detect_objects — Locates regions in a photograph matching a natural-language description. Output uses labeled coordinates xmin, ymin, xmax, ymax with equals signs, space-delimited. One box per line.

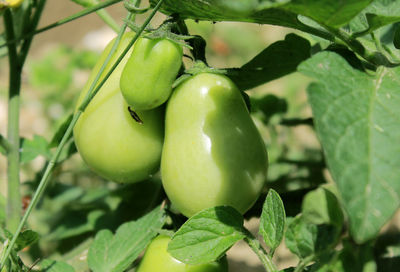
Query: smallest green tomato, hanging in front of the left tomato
xmin=120 ymin=38 xmax=183 ymax=110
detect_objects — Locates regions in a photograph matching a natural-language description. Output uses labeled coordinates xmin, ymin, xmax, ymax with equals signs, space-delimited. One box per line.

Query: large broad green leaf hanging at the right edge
xmin=299 ymin=52 xmax=400 ymax=242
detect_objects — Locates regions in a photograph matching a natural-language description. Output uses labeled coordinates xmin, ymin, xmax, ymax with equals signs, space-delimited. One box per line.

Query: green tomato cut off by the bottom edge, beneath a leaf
xmin=136 ymin=235 xmax=228 ymax=272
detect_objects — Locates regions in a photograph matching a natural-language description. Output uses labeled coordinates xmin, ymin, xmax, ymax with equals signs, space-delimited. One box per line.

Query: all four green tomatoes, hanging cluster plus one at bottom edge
xmin=74 ymin=32 xmax=267 ymax=272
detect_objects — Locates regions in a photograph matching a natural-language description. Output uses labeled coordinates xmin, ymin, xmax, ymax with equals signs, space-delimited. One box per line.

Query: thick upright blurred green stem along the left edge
xmin=4 ymin=9 xmax=22 ymax=232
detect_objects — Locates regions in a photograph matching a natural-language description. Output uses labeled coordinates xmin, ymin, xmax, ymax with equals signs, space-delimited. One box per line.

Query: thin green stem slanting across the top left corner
xmin=0 ymin=0 xmax=122 ymax=48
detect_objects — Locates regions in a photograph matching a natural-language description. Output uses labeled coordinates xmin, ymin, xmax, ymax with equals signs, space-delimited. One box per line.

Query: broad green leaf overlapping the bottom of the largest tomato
xmin=168 ymin=206 xmax=245 ymax=265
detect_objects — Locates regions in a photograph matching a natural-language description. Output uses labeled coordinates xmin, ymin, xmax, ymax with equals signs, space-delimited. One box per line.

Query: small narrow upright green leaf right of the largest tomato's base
xmin=259 ymin=189 xmax=286 ymax=255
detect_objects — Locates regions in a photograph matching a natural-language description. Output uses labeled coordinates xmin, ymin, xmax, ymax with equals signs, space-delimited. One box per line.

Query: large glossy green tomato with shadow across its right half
xmin=161 ymin=73 xmax=268 ymax=217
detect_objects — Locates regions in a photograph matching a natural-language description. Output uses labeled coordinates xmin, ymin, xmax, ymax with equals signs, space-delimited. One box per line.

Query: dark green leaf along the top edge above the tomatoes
xmin=150 ymin=0 xmax=372 ymax=30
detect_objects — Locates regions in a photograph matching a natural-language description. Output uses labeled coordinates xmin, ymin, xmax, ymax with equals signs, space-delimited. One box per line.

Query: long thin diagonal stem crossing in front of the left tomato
xmin=0 ymin=0 xmax=164 ymax=269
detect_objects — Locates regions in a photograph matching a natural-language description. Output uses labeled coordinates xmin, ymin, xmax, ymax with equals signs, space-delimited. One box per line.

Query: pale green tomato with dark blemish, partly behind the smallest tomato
xmin=74 ymin=33 xmax=164 ymax=182
